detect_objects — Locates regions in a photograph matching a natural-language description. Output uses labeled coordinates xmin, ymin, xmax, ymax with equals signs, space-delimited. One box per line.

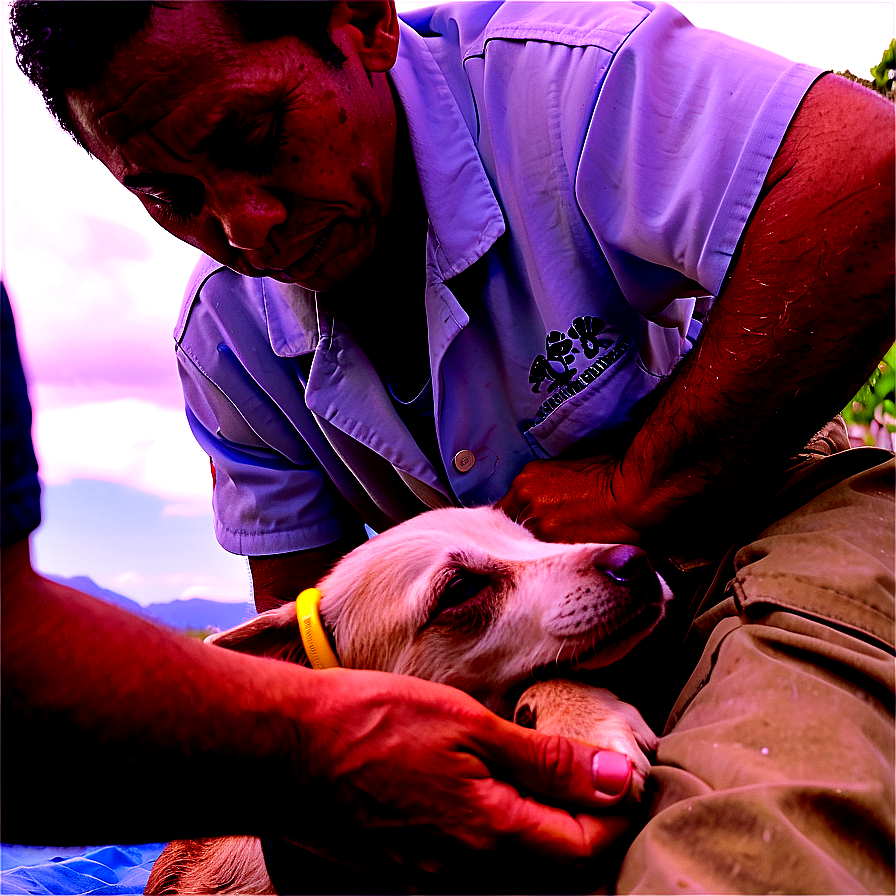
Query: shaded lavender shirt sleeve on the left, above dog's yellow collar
xmin=177 ymin=272 xmax=361 ymax=556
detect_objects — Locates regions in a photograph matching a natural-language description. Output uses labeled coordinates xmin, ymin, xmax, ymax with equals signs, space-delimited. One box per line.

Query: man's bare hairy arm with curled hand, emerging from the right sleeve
xmin=500 ymin=75 xmax=894 ymax=542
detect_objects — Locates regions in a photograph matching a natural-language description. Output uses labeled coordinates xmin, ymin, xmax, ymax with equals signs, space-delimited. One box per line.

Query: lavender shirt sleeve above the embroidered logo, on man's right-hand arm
xmin=576 ymin=3 xmax=821 ymax=322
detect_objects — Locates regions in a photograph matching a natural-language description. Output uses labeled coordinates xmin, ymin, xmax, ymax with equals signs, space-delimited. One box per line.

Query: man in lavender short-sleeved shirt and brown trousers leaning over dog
xmin=8 ymin=3 xmax=893 ymax=890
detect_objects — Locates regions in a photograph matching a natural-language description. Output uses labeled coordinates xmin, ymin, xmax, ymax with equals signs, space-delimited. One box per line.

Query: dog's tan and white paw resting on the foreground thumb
xmin=513 ymin=679 xmax=659 ymax=800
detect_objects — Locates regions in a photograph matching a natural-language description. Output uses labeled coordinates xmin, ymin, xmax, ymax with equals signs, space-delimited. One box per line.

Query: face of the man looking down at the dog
xmin=68 ymin=3 xmax=395 ymax=290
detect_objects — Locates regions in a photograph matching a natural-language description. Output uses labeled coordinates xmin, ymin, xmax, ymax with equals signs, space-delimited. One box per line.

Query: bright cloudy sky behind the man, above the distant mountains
xmin=0 ymin=0 xmax=896 ymax=605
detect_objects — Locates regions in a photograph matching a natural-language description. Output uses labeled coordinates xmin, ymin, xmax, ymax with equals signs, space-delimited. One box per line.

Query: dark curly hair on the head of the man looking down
xmin=10 ymin=0 xmax=345 ymax=149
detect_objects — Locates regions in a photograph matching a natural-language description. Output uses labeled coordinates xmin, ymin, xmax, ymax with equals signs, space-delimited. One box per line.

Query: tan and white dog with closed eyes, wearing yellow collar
xmin=145 ymin=507 xmax=672 ymax=894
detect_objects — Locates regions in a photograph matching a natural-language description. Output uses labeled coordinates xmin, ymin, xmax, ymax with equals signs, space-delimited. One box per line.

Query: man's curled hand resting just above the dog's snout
xmin=497 ymin=457 xmax=642 ymax=544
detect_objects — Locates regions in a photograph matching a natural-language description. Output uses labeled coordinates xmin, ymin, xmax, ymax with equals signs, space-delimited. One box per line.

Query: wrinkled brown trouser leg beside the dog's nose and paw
xmin=616 ymin=449 xmax=896 ymax=893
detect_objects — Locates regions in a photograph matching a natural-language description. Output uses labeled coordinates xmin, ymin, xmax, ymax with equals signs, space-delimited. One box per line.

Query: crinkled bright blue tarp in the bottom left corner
xmin=0 ymin=843 xmax=165 ymax=896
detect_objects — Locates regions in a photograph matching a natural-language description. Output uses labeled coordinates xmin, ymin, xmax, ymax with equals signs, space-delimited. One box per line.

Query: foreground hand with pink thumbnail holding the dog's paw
xmin=296 ymin=669 xmax=631 ymax=871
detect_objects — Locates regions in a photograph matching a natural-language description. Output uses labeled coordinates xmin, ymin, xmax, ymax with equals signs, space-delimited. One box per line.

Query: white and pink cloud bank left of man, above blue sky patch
xmin=0 ymin=40 xmax=211 ymax=514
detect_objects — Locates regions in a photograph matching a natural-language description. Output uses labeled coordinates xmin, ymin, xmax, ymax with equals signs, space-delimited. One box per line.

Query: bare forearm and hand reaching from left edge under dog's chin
xmin=0 ymin=541 xmax=627 ymax=861
